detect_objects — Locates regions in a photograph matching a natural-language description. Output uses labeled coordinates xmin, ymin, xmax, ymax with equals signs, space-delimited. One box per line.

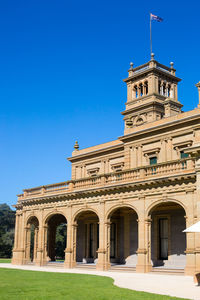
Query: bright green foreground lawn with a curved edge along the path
xmin=0 ymin=268 xmax=189 ymax=300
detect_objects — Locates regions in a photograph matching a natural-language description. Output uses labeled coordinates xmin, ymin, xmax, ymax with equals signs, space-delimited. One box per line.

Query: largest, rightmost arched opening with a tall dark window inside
xmin=150 ymin=201 xmax=186 ymax=269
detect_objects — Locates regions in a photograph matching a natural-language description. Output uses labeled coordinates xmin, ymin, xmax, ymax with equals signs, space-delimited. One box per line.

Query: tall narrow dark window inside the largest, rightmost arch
xmin=159 ymin=218 xmax=168 ymax=260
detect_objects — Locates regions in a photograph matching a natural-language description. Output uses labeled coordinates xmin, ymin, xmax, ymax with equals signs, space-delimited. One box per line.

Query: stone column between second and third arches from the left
xmin=64 ymin=222 xmax=78 ymax=268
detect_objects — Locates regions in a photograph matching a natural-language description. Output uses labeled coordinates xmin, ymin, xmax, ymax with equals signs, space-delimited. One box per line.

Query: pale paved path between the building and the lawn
xmin=0 ymin=263 xmax=200 ymax=300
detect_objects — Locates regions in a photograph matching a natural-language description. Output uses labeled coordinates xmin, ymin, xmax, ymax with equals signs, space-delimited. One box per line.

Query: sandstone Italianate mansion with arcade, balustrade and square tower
xmin=12 ymin=54 xmax=200 ymax=275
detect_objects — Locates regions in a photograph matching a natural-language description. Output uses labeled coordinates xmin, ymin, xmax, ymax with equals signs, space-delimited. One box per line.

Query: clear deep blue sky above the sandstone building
xmin=0 ymin=0 xmax=200 ymax=205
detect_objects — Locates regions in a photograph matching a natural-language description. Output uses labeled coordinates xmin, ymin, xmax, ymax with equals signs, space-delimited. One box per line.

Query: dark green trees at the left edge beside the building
xmin=0 ymin=203 xmax=15 ymax=258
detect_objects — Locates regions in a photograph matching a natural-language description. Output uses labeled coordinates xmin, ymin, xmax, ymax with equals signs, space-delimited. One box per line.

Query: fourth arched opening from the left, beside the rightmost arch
xmin=109 ymin=207 xmax=138 ymax=267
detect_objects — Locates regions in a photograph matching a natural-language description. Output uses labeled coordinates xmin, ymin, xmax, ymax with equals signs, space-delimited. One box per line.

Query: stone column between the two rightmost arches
xmin=136 ymin=217 xmax=152 ymax=273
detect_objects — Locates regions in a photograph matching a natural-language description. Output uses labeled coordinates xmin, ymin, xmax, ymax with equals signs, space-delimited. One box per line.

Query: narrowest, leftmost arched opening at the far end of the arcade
xmin=25 ymin=216 xmax=39 ymax=262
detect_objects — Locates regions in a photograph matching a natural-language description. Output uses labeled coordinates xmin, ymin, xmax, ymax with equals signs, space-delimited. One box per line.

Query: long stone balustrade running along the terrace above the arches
xmin=18 ymin=158 xmax=194 ymax=200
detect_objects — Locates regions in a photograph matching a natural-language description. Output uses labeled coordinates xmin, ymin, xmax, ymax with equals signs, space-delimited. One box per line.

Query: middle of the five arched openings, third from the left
xmin=75 ymin=211 xmax=99 ymax=264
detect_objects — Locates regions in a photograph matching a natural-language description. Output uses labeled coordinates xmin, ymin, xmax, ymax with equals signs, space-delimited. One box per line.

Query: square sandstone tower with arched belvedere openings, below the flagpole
xmin=122 ymin=53 xmax=182 ymax=134
